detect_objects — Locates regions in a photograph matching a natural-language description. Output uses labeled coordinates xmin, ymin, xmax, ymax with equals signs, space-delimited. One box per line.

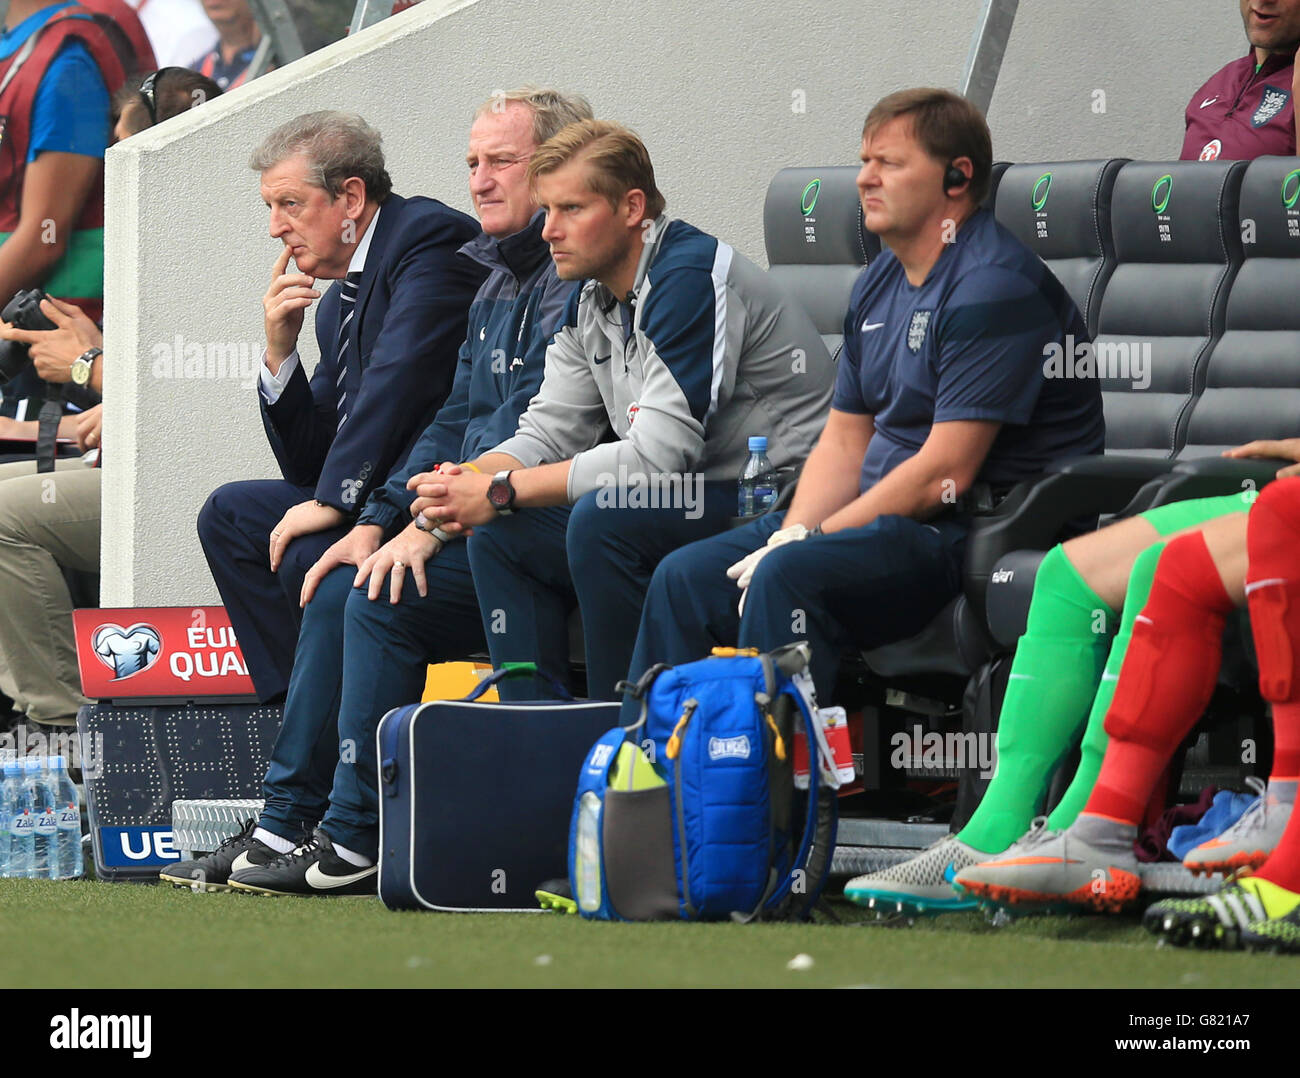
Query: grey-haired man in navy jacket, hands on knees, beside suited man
xmin=163 ymin=91 xmax=590 ymax=895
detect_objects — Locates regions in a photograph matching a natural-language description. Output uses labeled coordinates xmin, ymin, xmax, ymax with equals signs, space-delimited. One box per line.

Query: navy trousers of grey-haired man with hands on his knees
xmin=259 ymin=542 xmax=485 ymax=857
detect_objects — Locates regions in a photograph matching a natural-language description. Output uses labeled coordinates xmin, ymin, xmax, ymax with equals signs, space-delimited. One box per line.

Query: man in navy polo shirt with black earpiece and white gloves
xmin=613 ymin=88 xmax=1105 ymax=719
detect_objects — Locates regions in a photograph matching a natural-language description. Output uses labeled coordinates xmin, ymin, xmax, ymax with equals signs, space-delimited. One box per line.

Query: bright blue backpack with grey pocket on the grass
xmin=569 ymin=644 xmax=839 ymax=921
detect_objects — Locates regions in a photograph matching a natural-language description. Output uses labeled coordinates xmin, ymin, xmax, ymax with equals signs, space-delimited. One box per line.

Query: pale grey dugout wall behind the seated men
xmin=101 ymin=0 xmax=1245 ymax=606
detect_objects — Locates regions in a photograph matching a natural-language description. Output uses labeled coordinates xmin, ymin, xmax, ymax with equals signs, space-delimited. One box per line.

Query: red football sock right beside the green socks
xmin=1083 ymin=532 xmax=1232 ymax=824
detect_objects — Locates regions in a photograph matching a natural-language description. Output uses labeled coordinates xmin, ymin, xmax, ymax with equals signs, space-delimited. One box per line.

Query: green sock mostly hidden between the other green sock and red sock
xmin=1048 ymin=492 xmax=1253 ymax=831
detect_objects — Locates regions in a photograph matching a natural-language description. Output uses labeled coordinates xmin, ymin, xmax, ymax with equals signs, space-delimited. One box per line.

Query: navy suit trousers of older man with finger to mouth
xmin=199 ymin=479 xmax=348 ymax=702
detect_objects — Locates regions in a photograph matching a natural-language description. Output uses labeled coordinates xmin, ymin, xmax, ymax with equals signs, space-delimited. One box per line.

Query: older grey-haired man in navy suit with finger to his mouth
xmin=199 ymin=112 xmax=486 ymax=700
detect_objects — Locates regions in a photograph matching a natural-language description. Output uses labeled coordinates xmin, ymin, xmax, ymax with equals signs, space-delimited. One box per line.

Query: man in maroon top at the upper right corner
xmin=1179 ymin=0 xmax=1300 ymax=161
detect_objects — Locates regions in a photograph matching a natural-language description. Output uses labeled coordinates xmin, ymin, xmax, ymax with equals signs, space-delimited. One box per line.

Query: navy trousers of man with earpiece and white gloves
xmin=623 ymin=512 xmax=969 ymax=724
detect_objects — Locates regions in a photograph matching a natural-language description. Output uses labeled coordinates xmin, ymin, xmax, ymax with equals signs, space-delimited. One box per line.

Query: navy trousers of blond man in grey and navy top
xmin=469 ymin=482 xmax=736 ymax=700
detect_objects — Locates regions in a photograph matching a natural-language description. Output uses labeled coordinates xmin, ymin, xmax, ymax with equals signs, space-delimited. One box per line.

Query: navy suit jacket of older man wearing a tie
xmin=257 ymin=195 xmax=488 ymax=516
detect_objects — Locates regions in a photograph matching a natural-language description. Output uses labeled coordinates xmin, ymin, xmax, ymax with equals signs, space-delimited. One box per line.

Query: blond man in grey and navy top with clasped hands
xmin=417 ymin=121 xmax=833 ymax=698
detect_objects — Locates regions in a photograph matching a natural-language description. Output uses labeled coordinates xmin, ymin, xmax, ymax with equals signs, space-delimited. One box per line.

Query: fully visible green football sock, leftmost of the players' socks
xmin=957 ymin=546 xmax=1115 ymax=853
